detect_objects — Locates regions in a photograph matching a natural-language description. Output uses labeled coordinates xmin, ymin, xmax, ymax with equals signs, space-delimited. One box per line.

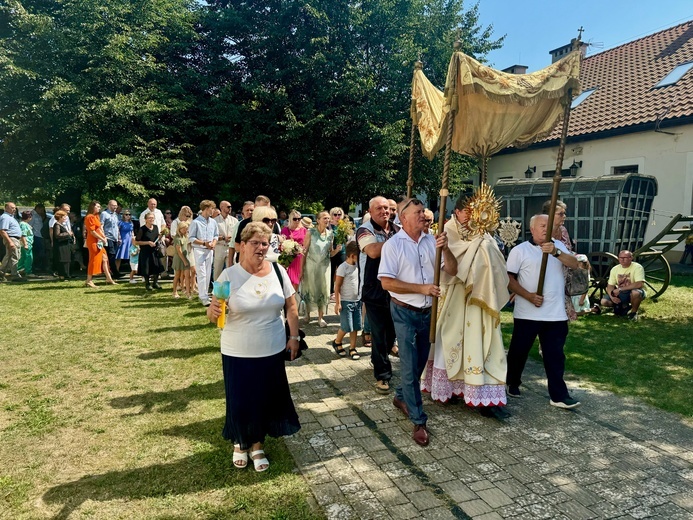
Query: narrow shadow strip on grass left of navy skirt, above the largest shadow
xmin=111 ymin=379 xmax=225 ymax=417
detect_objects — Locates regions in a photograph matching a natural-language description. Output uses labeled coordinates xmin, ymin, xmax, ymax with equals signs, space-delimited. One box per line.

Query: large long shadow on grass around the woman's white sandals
xmin=42 ymin=417 xmax=304 ymax=520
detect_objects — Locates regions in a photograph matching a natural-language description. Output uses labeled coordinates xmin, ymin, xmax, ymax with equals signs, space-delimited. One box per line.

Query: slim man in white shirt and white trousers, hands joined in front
xmin=188 ymin=200 xmax=219 ymax=307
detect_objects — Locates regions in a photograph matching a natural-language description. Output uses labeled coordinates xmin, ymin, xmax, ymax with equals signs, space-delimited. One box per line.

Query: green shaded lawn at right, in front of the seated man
xmin=503 ymin=276 xmax=693 ymax=417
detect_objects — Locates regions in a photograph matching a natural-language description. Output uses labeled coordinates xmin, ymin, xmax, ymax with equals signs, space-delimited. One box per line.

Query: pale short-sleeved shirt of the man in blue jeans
xmin=378 ymin=229 xmax=436 ymax=309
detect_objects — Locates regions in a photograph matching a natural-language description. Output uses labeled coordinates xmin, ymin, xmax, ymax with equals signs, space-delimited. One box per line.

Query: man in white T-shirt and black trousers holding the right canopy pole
xmin=506 ymin=215 xmax=580 ymax=409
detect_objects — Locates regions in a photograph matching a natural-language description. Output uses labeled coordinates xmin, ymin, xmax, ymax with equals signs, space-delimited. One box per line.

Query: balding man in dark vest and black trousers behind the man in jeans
xmin=356 ymin=196 xmax=399 ymax=394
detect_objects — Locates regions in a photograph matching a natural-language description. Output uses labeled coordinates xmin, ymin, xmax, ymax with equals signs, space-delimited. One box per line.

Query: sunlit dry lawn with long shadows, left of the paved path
xmin=0 ymin=281 xmax=322 ymax=520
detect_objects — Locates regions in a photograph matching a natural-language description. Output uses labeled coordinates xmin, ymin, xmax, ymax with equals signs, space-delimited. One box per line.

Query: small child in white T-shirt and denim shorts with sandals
xmin=332 ymin=241 xmax=361 ymax=360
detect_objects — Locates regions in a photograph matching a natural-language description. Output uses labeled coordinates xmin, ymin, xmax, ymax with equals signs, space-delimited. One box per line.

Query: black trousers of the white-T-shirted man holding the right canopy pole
xmin=506 ymin=319 xmax=568 ymax=401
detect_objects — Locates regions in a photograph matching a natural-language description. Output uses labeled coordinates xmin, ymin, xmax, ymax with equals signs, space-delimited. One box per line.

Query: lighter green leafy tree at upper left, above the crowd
xmin=0 ymin=0 xmax=200 ymax=203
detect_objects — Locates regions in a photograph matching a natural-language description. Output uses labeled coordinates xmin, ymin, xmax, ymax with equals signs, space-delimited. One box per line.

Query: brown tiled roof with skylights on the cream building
xmin=542 ymin=21 xmax=693 ymax=142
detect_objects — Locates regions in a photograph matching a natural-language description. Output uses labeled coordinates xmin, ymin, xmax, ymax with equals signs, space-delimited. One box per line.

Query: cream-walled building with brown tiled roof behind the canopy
xmin=488 ymin=21 xmax=693 ymax=259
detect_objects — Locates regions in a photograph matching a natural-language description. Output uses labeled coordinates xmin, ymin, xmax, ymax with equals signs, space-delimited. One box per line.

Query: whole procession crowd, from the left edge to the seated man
xmin=0 ymin=195 xmax=645 ymax=471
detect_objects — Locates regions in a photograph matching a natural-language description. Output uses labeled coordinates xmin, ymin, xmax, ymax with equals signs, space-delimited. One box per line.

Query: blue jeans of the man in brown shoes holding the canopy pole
xmin=390 ymin=302 xmax=431 ymax=424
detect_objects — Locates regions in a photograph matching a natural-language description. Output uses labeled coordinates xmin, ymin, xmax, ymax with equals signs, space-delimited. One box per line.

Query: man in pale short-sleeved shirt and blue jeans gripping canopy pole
xmin=378 ymin=199 xmax=457 ymax=446
